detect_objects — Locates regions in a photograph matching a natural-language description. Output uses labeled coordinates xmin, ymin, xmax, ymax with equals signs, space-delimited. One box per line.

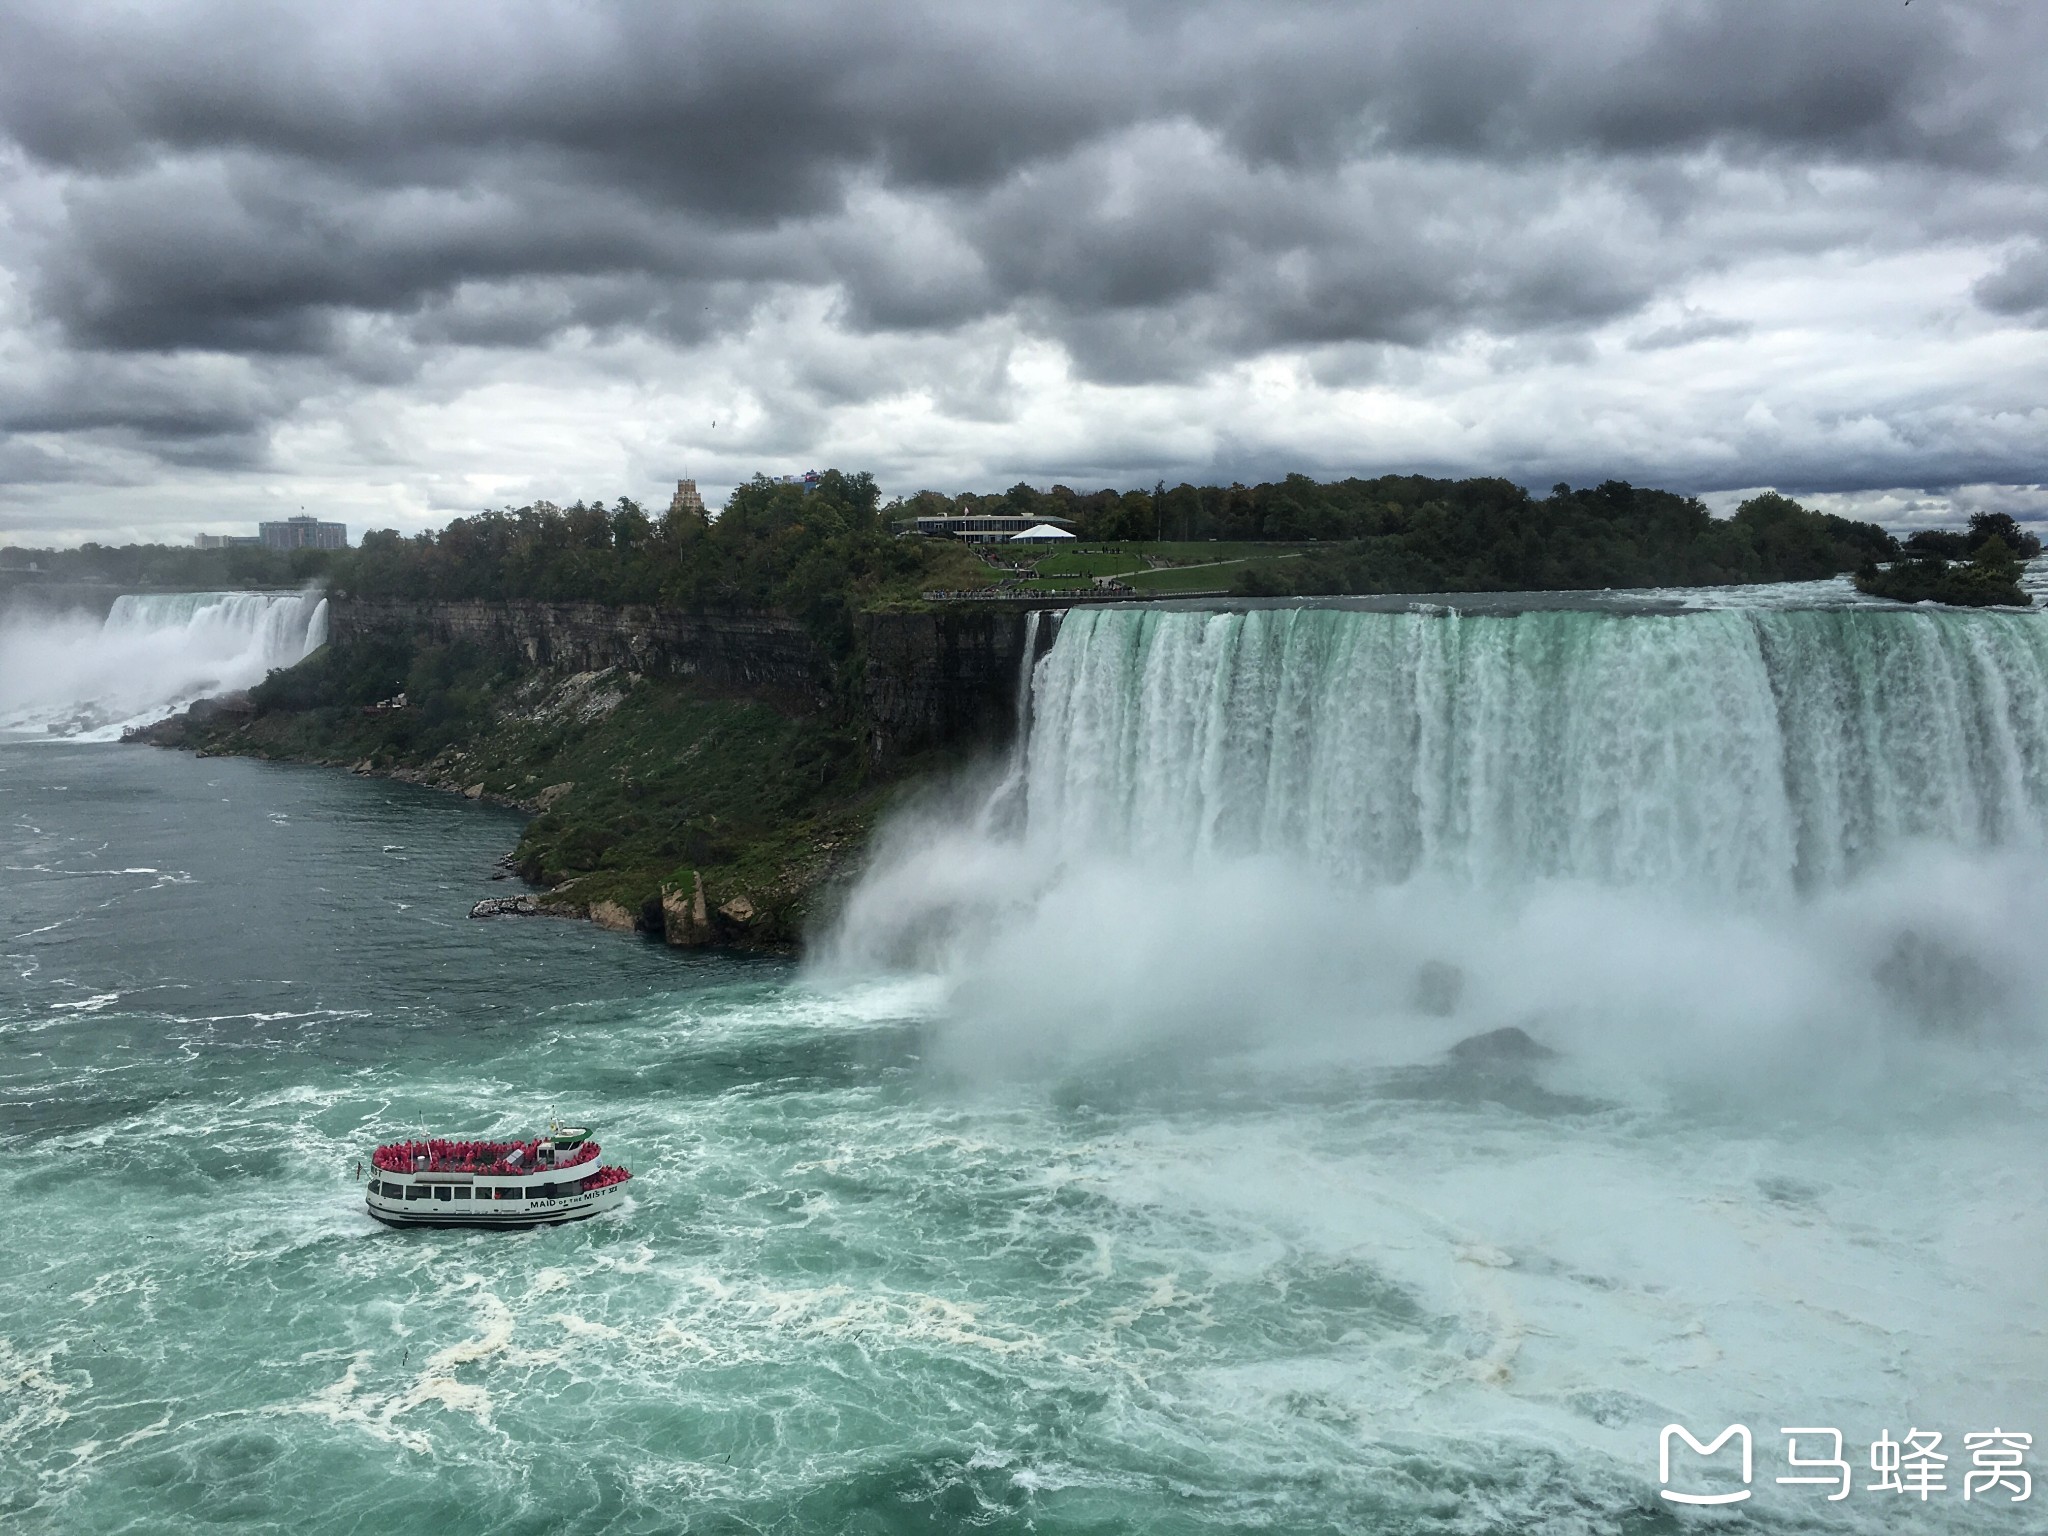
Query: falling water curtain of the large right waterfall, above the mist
xmin=1028 ymin=608 xmax=2048 ymax=897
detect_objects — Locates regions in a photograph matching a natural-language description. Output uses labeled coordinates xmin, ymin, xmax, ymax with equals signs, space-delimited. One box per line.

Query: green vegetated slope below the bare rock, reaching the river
xmin=156 ymin=639 xmax=883 ymax=948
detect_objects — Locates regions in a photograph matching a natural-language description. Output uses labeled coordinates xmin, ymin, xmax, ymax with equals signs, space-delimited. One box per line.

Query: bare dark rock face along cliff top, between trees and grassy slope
xmin=328 ymin=594 xmax=1051 ymax=772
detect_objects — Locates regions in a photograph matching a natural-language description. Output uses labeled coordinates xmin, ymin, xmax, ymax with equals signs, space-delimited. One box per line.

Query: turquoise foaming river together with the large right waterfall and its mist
xmin=0 ymin=593 xmax=2048 ymax=1532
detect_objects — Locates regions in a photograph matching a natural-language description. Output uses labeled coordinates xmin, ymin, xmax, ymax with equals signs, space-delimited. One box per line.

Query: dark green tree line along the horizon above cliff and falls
xmin=8 ymin=469 xmax=1998 ymax=626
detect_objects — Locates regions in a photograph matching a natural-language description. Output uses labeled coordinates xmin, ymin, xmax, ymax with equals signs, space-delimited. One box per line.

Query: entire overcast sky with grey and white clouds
xmin=0 ymin=0 xmax=2048 ymax=543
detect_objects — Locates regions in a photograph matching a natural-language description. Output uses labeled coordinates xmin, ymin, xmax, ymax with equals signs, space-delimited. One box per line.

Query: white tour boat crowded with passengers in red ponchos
xmin=369 ymin=1124 xmax=633 ymax=1227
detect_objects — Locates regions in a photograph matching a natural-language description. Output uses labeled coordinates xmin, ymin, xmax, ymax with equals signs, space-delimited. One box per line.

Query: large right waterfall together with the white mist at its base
xmin=834 ymin=608 xmax=2048 ymax=1055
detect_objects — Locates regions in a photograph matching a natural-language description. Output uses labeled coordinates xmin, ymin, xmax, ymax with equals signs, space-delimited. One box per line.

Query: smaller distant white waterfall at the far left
xmin=0 ymin=590 xmax=328 ymax=739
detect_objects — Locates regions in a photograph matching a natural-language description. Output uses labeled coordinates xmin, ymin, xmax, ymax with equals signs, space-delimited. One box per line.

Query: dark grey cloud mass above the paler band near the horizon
xmin=0 ymin=0 xmax=2048 ymax=536
